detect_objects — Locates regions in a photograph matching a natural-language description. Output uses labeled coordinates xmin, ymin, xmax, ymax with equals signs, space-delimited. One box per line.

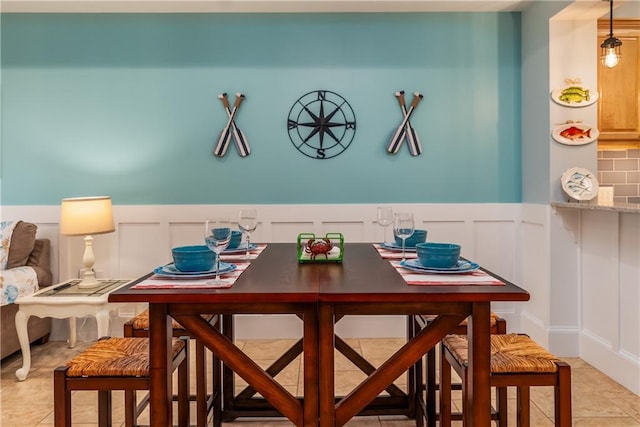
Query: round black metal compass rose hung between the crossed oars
xmin=287 ymin=90 xmax=356 ymax=159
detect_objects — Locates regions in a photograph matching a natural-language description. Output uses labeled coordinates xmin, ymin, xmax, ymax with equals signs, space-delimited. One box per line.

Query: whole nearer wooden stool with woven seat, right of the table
xmin=440 ymin=334 xmax=572 ymax=427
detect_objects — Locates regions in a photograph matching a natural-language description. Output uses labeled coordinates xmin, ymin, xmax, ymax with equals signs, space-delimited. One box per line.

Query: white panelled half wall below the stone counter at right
xmin=550 ymin=206 xmax=640 ymax=394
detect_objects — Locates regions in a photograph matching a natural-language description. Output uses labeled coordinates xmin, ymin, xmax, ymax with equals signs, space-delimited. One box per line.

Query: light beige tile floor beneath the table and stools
xmin=0 ymin=339 xmax=640 ymax=427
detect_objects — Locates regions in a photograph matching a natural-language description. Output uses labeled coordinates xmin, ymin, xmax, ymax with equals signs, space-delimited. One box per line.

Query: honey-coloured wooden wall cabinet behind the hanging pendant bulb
xmin=598 ymin=19 xmax=640 ymax=147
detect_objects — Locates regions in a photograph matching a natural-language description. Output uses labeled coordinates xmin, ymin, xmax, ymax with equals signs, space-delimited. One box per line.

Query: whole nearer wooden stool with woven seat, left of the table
xmin=53 ymin=337 xmax=189 ymax=427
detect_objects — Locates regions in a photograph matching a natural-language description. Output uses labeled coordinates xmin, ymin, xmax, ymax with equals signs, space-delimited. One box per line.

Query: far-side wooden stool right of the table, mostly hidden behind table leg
xmin=409 ymin=312 xmax=507 ymax=427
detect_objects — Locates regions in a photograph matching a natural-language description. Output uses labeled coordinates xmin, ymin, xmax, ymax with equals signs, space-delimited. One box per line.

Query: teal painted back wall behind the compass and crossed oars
xmin=0 ymin=13 xmax=522 ymax=205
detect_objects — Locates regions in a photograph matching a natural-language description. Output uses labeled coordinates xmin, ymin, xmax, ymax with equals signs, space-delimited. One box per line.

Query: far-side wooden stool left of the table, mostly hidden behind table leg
xmin=124 ymin=309 xmax=222 ymax=427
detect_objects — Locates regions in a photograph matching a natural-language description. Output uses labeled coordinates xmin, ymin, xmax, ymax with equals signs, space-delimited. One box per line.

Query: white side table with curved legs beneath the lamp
xmin=16 ymin=279 xmax=131 ymax=381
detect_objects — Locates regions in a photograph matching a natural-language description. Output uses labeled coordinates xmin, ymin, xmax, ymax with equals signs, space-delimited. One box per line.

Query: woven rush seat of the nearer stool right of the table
xmin=443 ymin=334 xmax=559 ymax=374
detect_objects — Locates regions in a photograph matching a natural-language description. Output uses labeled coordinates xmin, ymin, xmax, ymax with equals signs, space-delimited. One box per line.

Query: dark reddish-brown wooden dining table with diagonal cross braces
xmin=109 ymin=243 xmax=529 ymax=427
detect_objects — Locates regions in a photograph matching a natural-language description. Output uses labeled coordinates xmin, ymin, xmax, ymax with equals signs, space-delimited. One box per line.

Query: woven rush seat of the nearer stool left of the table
xmin=67 ymin=338 xmax=184 ymax=377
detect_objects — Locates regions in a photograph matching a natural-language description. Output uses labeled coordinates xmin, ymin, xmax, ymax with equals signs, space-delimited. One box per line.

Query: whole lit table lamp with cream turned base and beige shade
xmin=60 ymin=196 xmax=115 ymax=288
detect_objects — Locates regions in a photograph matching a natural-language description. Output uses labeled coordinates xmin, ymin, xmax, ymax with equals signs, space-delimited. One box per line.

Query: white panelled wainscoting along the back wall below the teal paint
xmin=2 ymin=204 xmax=523 ymax=339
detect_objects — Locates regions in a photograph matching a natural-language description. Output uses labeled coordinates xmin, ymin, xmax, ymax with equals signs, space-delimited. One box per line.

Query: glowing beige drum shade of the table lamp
xmin=60 ymin=196 xmax=115 ymax=236
